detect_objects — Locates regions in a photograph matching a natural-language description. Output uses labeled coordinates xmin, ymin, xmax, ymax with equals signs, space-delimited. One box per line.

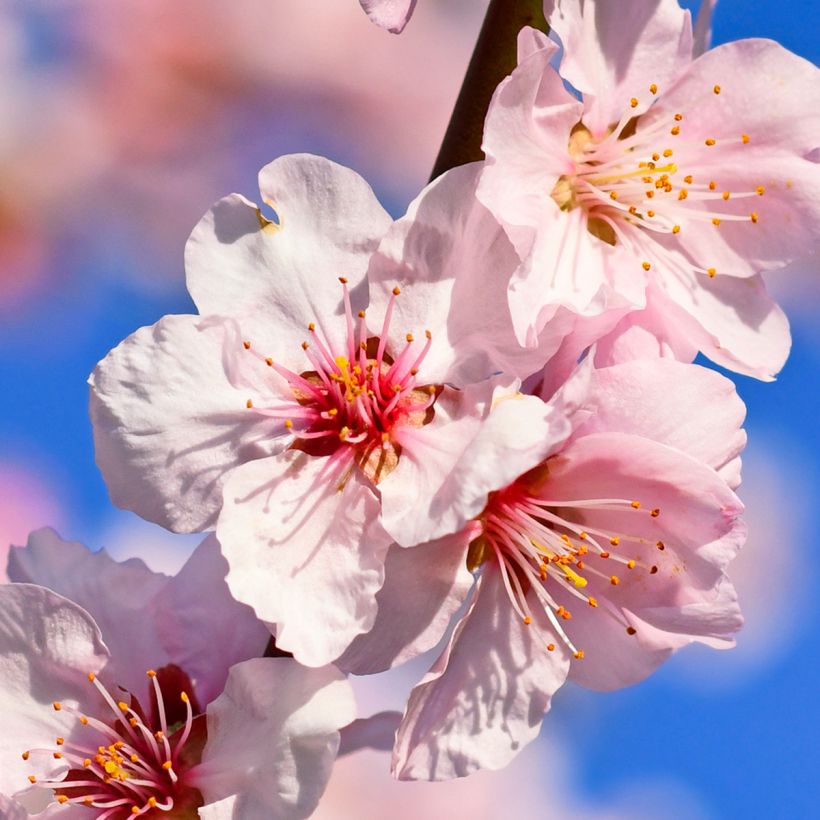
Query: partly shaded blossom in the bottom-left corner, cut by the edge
xmin=0 ymin=530 xmax=354 ymax=820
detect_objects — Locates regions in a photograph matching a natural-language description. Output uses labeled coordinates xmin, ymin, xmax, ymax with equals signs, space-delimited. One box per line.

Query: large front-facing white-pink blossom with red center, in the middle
xmin=91 ymin=155 xmax=540 ymax=666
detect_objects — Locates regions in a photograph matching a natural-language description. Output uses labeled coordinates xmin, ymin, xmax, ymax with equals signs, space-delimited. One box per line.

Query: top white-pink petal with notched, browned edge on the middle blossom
xmin=185 ymin=154 xmax=391 ymax=355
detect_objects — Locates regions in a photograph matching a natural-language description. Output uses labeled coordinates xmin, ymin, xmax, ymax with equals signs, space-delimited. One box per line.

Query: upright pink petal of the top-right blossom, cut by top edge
xmin=544 ymin=0 xmax=692 ymax=136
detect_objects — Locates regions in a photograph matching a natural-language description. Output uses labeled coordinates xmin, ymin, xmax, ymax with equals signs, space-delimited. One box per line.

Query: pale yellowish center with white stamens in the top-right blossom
xmin=552 ymin=83 xmax=765 ymax=276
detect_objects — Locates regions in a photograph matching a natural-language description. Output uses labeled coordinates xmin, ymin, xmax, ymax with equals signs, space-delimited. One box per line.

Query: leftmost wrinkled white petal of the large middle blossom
xmin=89 ymin=316 xmax=283 ymax=532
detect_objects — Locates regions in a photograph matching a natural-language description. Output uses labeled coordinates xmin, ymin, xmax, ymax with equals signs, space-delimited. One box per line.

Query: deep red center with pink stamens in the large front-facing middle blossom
xmin=244 ymin=278 xmax=439 ymax=483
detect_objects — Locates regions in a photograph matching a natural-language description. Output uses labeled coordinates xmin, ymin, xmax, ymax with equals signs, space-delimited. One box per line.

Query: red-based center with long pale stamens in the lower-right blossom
xmin=467 ymin=463 xmax=665 ymax=659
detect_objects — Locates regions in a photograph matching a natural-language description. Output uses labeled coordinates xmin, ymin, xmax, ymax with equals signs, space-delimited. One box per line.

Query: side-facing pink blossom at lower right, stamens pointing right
xmin=350 ymin=359 xmax=745 ymax=780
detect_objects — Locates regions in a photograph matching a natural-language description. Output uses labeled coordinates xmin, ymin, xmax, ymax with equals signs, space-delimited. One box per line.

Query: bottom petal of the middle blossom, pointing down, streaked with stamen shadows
xmin=217 ymin=450 xmax=390 ymax=666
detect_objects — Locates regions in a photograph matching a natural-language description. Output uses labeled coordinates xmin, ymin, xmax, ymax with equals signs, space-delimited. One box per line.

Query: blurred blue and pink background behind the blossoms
xmin=0 ymin=0 xmax=820 ymax=820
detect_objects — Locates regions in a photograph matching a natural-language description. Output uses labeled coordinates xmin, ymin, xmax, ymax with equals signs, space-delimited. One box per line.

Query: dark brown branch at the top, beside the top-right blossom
xmin=430 ymin=0 xmax=548 ymax=180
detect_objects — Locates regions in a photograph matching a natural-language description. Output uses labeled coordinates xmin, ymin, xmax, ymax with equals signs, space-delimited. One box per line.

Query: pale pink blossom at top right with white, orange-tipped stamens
xmin=478 ymin=0 xmax=820 ymax=379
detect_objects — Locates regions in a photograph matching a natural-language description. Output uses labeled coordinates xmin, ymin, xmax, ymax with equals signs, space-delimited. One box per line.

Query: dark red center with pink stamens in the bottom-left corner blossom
xmin=23 ymin=666 xmax=202 ymax=820
